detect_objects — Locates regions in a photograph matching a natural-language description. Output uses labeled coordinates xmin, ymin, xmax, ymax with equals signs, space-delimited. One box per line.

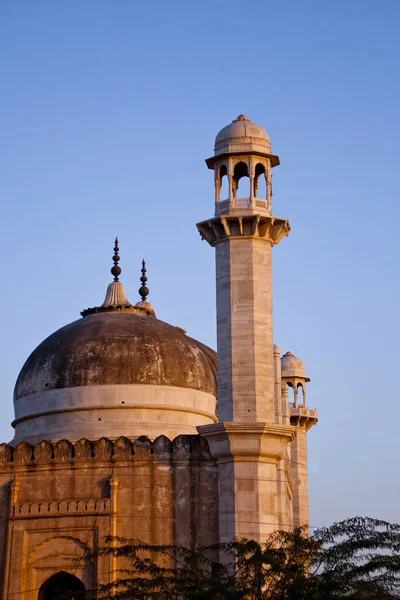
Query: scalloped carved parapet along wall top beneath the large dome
xmin=0 ymin=435 xmax=216 ymax=470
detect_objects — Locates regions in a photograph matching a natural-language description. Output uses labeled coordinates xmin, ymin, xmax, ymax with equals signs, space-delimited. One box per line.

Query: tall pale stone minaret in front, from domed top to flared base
xmin=197 ymin=115 xmax=295 ymax=541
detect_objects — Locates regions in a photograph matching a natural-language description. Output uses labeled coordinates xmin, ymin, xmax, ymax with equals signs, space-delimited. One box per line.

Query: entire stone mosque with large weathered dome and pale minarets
xmin=0 ymin=115 xmax=317 ymax=600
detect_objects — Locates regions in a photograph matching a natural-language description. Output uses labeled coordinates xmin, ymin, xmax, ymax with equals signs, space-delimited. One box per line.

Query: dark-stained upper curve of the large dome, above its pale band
xmin=14 ymin=312 xmax=216 ymax=400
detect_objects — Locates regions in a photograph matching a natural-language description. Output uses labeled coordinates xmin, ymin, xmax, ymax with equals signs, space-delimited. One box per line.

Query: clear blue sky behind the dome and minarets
xmin=0 ymin=0 xmax=400 ymax=525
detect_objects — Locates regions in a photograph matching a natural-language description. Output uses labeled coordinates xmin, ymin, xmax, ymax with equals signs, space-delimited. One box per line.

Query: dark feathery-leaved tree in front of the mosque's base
xmin=89 ymin=517 xmax=400 ymax=600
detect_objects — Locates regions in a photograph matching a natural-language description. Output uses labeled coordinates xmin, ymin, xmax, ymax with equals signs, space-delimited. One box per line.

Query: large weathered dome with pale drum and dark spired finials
xmin=13 ymin=242 xmax=216 ymax=443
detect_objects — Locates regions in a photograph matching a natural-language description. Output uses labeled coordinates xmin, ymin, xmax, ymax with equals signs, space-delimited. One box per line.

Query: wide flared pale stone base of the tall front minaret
xmin=197 ymin=422 xmax=295 ymax=543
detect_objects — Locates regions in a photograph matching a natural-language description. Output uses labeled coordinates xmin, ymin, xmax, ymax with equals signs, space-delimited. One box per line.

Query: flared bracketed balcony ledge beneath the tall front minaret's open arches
xmin=196 ymin=214 xmax=290 ymax=246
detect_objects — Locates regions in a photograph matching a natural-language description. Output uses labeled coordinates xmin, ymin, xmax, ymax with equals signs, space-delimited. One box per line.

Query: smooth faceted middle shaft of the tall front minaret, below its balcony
xmin=216 ymin=237 xmax=276 ymax=423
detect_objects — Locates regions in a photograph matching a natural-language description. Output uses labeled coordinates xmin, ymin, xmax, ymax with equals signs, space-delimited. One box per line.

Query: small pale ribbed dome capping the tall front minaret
xmin=214 ymin=115 xmax=271 ymax=156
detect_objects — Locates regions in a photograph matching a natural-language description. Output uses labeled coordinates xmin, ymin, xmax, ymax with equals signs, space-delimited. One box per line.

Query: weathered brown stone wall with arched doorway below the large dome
xmin=0 ymin=435 xmax=219 ymax=600
